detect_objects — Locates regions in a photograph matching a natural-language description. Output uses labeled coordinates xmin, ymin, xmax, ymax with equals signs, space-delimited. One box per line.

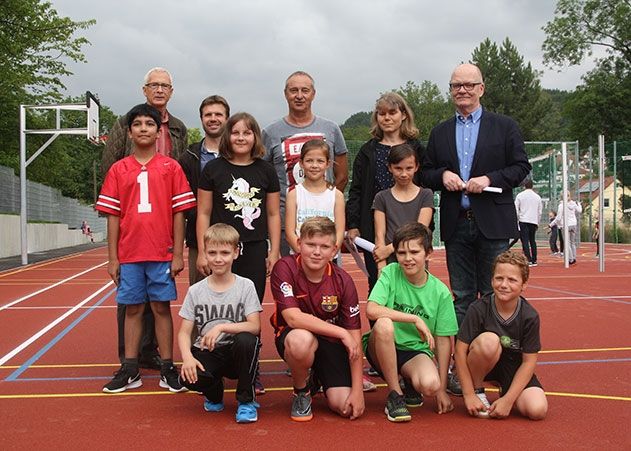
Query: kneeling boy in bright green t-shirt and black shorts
xmin=364 ymin=223 xmax=458 ymax=422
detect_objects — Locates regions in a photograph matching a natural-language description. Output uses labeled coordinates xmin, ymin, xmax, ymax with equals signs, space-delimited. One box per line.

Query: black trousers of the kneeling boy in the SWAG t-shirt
xmin=182 ymin=332 xmax=259 ymax=403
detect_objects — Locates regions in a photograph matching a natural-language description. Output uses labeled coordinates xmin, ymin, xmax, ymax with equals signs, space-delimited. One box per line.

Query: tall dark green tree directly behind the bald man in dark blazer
xmin=471 ymin=38 xmax=560 ymax=141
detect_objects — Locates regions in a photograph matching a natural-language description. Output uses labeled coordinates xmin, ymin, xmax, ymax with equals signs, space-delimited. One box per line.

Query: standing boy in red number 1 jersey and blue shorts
xmin=96 ymin=104 xmax=195 ymax=393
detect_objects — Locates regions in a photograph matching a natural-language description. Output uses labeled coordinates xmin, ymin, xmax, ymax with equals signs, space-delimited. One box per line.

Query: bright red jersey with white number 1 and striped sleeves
xmin=96 ymin=154 xmax=196 ymax=263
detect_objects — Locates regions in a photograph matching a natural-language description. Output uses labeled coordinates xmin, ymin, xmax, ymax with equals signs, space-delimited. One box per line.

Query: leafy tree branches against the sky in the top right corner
xmin=543 ymin=0 xmax=631 ymax=67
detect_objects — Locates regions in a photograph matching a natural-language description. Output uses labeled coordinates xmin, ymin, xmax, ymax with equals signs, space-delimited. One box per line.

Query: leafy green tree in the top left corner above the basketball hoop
xmin=0 ymin=0 xmax=95 ymax=167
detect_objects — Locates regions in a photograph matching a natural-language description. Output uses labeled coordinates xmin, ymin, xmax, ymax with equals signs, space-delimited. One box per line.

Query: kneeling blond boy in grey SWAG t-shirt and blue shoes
xmin=178 ymin=223 xmax=262 ymax=423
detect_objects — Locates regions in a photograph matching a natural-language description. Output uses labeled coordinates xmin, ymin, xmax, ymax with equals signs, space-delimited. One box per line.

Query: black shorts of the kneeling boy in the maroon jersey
xmin=276 ymin=327 xmax=352 ymax=391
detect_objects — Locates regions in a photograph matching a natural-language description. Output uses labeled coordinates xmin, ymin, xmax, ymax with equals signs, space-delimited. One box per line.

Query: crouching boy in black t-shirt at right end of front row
xmin=455 ymin=251 xmax=548 ymax=420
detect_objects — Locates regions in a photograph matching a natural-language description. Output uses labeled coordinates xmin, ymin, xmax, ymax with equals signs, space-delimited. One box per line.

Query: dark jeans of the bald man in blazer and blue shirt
xmin=445 ymin=218 xmax=508 ymax=326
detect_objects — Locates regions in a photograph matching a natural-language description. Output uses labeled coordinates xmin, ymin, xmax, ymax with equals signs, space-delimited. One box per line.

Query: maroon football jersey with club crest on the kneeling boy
xmin=270 ymin=255 xmax=361 ymax=335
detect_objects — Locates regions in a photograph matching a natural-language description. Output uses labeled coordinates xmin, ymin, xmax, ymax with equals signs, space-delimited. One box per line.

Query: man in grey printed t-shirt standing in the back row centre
xmin=263 ymin=71 xmax=348 ymax=255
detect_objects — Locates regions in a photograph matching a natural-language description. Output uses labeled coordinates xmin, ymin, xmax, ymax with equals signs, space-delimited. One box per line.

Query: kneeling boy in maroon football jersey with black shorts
xmin=270 ymin=216 xmax=364 ymax=421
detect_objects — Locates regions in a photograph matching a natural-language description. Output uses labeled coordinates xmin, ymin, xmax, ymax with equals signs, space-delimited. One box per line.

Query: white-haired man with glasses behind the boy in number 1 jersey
xmin=101 ymin=67 xmax=188 ymax=370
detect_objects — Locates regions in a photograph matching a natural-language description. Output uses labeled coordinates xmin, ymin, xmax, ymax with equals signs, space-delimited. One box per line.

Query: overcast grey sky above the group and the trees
xmin=51 ymin=0 xmax=593 ymax=132
